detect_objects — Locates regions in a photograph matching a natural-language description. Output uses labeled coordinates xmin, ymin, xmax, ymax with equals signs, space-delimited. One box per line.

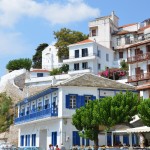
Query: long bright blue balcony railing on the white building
xmin=14 ymin=106 xmax=58 ymax=124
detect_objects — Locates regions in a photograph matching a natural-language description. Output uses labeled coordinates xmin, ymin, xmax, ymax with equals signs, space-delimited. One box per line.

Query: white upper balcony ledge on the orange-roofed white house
xmin=63 ymin=53 xmax=98 ymax=63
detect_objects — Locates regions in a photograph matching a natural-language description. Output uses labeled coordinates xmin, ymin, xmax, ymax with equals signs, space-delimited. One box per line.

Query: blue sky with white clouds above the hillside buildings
xmin=0 ymin=0 xmax=150 ymax=77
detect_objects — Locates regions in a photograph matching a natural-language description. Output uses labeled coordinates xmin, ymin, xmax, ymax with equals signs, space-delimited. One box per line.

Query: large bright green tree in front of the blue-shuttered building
xmin=72 ymin=91 xmax=139 ymax=146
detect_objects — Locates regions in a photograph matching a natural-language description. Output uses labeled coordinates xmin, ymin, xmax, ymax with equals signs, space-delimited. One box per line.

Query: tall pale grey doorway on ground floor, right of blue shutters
xmin=39 ymin=129 xmax=47 ymax=150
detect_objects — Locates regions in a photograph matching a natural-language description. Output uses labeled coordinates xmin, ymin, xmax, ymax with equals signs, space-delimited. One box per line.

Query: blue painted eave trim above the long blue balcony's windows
xmin=18 ymin=88 xmax=58 ymax=105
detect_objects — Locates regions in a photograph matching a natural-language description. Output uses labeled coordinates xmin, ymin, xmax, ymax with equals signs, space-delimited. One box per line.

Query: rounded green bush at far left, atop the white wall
xmin=6 ymin=58 xmax=32 ymax=71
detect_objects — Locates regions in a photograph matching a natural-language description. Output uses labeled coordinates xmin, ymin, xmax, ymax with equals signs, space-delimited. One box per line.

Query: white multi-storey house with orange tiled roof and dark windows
xmin=63 ymin=39 xmax=115 ymax=75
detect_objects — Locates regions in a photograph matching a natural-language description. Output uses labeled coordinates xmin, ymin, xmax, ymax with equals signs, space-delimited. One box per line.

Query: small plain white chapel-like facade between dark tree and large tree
xmin=42 ymin=45 xmax=62 ymax=71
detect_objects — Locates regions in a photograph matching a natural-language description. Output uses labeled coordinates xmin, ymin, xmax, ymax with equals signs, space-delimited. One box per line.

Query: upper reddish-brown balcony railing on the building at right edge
xmin=127 ymin=52 xmax=150 ymax=64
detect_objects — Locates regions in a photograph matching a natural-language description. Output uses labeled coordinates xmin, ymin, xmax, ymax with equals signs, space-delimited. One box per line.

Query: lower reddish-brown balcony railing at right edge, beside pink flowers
xmin=128 ymin=72 xmax=150 ymax=82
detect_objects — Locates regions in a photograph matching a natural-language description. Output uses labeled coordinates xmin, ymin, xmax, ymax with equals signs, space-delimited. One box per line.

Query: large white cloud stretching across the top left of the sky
xmin=0 ymin=0 xmax=100 ymax=27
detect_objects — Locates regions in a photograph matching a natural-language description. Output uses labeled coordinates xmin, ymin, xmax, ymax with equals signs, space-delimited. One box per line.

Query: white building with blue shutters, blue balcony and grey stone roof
xmin=15 ymin=74 xmax=135 ymax=150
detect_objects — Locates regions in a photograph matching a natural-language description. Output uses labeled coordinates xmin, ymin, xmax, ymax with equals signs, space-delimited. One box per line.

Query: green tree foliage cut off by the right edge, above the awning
xmin=138 ymin=98 xmax=150 ymax=126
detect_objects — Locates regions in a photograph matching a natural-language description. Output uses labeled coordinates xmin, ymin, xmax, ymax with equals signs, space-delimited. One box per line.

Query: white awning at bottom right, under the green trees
xmin=126 ymin=126 xmax=150 ymax=133
